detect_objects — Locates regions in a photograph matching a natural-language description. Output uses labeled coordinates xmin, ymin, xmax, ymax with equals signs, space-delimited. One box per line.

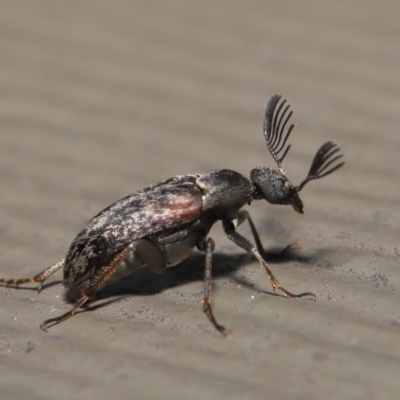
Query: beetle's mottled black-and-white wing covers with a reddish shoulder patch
xmin=64 ymin=175 xmax=203 ymax=286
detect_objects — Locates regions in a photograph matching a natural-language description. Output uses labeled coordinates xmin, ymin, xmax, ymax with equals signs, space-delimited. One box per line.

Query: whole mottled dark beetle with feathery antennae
xmin=0 ymin=95 xmax=344 ymax=336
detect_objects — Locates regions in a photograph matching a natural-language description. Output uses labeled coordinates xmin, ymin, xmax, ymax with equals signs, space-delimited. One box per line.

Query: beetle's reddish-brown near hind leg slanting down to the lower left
xmin=40 ymin=246 xmax=132 ymax=331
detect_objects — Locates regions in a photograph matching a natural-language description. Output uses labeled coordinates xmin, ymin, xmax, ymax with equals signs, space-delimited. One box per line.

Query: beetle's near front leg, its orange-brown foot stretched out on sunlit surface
xmin=223 ymin=210 xmax=316 ymax=301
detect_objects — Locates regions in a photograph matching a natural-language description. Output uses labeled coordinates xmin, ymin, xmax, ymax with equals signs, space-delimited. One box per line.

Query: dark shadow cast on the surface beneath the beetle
xmin=88 ymin=244 xmax=329 ymax=310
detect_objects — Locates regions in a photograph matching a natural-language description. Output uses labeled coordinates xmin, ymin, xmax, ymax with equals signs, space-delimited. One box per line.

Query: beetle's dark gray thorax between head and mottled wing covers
xmin=196 ymin=169 xmax=252 ymax=219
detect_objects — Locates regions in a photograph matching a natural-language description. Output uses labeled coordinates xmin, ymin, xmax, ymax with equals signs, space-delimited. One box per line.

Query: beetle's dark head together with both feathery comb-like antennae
xmin=250 ymin=95 xmax=344 ymax=214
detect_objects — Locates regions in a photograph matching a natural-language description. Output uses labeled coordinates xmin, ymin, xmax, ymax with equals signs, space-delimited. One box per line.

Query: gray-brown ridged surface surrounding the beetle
xmin=0 ymin=0 xmax=400 ymax=400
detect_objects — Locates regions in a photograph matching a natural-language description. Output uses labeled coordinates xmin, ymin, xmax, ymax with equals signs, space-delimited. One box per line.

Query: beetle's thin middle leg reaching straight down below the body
xmin=198 ymin=238 xmax=231 ymax=336
